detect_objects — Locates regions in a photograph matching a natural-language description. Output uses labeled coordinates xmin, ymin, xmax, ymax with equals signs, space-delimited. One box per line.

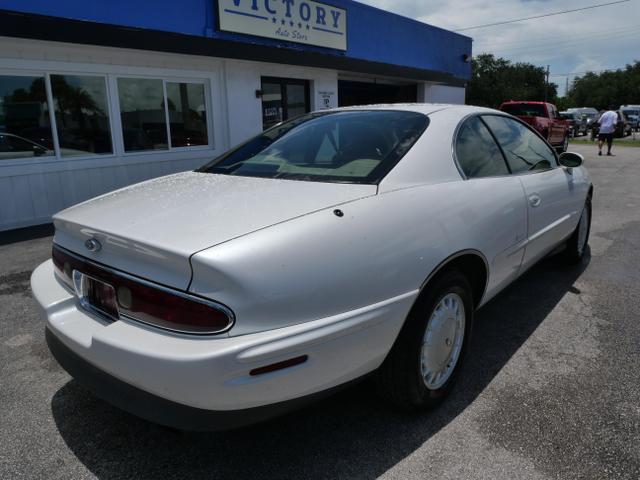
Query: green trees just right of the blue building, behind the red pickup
xmin=467 ymin=53 xmax=558 ymax=108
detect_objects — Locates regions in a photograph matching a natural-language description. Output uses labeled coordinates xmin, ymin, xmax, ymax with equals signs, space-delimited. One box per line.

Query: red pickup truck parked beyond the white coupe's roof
xmin=500 ymin=100 xmax=570 ymax=153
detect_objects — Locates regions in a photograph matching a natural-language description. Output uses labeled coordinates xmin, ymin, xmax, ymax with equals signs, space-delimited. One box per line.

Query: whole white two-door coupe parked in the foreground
xmin=31 ymin=105 xmax=593 ymax=430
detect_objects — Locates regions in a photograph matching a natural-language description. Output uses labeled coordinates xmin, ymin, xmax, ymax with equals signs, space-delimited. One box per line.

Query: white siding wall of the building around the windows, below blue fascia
xmin=0 ymin=37 xmax=338 ymax=231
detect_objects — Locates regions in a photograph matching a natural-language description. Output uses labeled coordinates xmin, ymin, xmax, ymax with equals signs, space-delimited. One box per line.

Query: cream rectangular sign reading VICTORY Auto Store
xmin=218 ymin=0 xmax=347 ymax=50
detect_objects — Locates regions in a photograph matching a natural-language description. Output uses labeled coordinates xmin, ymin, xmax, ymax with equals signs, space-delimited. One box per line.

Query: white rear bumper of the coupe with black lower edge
xmin=31 ymin=261 xmax=417 ymax=430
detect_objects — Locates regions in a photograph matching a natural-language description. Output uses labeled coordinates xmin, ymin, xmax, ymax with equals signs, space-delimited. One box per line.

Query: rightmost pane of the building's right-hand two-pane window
xmin=167 ymin=82 xmax=209 ymax=148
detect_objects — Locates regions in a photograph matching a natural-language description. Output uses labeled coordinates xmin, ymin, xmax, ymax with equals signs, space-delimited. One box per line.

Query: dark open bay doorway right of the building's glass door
xmin=338 ymin=80 xmax=418 ymax=107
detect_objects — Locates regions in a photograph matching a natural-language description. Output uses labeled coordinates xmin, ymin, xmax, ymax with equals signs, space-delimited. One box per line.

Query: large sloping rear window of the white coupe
xmin=198 ymin=110 xmax=429 ymax=183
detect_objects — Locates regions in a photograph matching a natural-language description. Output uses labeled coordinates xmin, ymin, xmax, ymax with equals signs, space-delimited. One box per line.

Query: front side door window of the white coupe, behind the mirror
xmin=482 ymin=115 xmax=558 ymax=174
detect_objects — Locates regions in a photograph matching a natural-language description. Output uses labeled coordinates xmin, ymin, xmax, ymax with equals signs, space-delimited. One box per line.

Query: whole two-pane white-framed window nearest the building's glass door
xmin=118 ymin=78 xmax=209 ymax=152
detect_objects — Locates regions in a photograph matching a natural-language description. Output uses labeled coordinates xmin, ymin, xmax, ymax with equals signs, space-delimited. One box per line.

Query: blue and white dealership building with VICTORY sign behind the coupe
xmin=0 ymin=0 xmax=471 ymax=231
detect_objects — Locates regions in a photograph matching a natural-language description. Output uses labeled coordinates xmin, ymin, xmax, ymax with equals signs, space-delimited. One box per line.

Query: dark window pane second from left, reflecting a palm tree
xmin=51 ymin=75 xmax=113 ymax=157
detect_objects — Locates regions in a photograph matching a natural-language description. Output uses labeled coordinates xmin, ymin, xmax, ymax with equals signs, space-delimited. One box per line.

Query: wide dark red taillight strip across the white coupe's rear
xmin=52 ymin=245 xmax=233 ymax=334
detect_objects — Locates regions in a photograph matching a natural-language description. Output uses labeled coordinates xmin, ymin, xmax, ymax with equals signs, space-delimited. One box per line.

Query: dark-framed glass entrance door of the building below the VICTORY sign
xmin=262 ymin=77 xmax=311 ymax=130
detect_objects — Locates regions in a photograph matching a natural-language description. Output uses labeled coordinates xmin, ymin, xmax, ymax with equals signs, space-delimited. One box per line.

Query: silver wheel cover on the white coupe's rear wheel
xmin=420 ymin=293 xmax=465 ymax=390
